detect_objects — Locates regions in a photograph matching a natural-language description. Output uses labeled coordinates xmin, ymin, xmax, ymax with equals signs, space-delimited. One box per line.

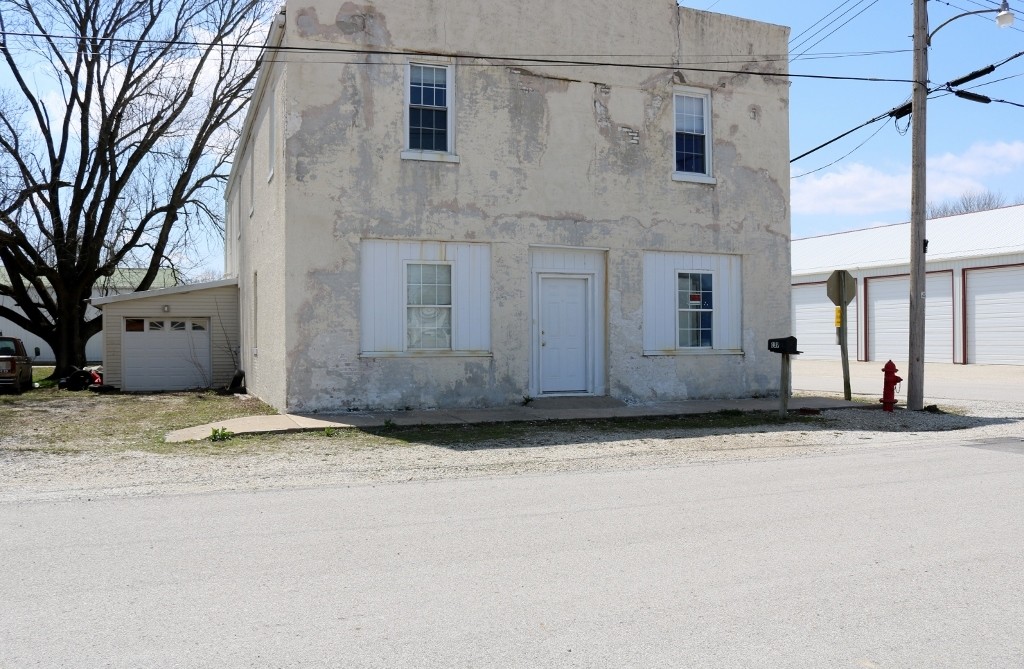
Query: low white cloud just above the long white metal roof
xmin=792 ymin=141 xmax=1024 ymax=216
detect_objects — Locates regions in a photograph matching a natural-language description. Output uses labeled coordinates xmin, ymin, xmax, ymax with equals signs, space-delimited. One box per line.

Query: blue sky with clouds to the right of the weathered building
xmin=680 ymin=0 xmax=1024 ymax=238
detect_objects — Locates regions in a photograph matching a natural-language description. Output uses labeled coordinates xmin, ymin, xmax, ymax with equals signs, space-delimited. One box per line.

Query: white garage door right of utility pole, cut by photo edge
xmin=967 ymin=267 xmax=1024 ymax=365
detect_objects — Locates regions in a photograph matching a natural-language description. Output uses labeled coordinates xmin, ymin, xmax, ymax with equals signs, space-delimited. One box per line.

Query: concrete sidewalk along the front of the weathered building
xmin=165 ymin=396 xmax=863 ymax=444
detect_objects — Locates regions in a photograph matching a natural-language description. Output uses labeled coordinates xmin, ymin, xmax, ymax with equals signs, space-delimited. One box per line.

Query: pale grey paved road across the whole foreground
xmin=0 ymin=435 xmax=1024 ymax=668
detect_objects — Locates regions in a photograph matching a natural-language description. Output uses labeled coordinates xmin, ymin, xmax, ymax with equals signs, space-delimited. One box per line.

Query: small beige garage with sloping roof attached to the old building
xmin=92 ymin=279 xmax=240 ymax=391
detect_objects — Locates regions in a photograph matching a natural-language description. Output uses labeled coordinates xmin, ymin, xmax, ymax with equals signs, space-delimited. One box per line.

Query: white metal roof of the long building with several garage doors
xmin=793 ymin=205 xmax=1024 ymax=275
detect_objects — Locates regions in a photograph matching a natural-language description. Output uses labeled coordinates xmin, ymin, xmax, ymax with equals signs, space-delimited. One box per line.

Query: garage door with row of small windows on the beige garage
xmin=121 ymin=318 xmax=213 ymax=390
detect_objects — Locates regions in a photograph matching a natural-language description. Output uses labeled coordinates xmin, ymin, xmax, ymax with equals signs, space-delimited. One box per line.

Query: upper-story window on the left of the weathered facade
xmin=401 ymin=62 xmax=458 ymax=162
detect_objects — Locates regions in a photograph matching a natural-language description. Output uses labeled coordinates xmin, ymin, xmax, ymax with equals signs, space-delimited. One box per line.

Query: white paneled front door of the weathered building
xmin=539 ymin=277 xmax=590 ymax=392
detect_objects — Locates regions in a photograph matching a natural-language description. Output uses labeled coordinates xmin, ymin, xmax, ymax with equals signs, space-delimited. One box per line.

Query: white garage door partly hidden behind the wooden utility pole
xmin=866 ymin=271 xmax=953 ymax=363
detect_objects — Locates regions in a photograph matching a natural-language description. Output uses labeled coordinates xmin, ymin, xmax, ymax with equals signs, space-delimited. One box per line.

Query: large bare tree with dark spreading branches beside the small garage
xmin=0 ymin=0 xmax=270 ymax=375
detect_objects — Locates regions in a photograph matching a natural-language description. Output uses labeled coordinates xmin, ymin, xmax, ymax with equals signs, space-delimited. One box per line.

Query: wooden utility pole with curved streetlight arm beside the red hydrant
xmin=906 ymin=0 xmax=1014 ymax=411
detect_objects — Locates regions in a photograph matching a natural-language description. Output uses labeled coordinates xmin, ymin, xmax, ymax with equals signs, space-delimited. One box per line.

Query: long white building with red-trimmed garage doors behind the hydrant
xmin=793 ymin=205 xmax=1024 ymax=365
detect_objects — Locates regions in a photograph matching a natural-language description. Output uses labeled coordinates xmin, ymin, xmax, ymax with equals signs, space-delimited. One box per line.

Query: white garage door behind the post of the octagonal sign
xmin=793 ymin=284 xmax=858 ymax=360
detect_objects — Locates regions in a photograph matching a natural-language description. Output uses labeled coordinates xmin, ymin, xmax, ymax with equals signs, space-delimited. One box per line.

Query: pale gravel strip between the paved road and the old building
xmin=0 ymin=402 xmax=1024 ymax=503
